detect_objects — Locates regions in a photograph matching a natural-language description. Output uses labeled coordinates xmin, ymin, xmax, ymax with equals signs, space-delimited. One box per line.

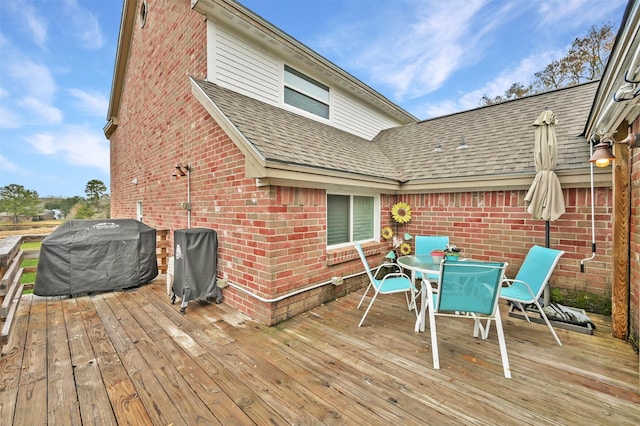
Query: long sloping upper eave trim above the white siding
xmin=191 ymin=0 xmax=419 ymax=124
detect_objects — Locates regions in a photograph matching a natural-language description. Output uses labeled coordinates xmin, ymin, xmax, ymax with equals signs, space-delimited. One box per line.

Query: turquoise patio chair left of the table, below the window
xmin=355 ymin=241 xmax=418 ymax=327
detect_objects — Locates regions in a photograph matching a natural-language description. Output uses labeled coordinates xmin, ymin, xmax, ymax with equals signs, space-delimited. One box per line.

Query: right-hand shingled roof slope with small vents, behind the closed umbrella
xmin=374 ymin=82 xmax=598 ymax=181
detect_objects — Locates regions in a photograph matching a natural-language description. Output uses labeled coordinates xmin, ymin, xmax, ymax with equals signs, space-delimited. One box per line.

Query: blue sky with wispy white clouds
xmin=0 ymin=0 xmax=627 ymax=197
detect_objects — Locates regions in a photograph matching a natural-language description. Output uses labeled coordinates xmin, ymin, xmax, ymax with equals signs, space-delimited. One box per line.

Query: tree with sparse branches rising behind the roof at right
xmin=479 ymin=25 xmax=615 ymax=106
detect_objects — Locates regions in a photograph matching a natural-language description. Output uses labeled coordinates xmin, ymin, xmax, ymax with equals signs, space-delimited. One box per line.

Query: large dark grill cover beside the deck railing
xmin=33 ymin=219 xmax=158 ymax=296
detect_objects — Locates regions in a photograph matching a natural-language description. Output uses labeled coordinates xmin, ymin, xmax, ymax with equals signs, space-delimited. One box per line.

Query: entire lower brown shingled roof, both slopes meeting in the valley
xmin=192 ymin=79 xmax=598 ymax=191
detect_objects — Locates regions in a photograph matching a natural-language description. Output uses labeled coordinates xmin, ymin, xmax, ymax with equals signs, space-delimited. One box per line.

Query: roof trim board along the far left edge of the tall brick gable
xmin=103 ymin=0 xmax=138 ymax=139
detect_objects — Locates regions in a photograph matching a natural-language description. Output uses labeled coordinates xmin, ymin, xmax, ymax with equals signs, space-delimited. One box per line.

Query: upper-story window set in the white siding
xmin=284 ymin=65 xmax=329 ymax=119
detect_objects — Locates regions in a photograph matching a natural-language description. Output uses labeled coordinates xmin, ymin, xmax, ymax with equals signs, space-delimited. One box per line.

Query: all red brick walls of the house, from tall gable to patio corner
xmin=111 ymin=0 xmax=611 ymax=324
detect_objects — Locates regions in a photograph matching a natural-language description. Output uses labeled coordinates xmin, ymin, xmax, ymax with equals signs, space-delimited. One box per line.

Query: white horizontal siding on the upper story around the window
xmin=207 ymin=21 xmax=403 ymax=140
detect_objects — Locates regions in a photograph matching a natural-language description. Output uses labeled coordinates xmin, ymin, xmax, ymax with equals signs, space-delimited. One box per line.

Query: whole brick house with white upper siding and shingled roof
xmin=104 ymin=0 xmax=637 ymax=350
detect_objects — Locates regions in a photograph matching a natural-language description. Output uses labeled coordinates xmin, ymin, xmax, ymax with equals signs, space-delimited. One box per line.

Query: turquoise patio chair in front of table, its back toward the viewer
xmin=426 ymin=261 xmax=511 ymax=378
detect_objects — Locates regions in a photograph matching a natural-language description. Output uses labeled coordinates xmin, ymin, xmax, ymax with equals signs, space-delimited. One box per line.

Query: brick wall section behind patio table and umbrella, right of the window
xmin=378 ymin=188 xmax=612 ymax=296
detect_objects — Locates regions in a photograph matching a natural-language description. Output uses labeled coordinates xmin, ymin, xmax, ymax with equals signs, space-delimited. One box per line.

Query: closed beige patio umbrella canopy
xmin=524 ymin=109 xmax=565 ymax=223
